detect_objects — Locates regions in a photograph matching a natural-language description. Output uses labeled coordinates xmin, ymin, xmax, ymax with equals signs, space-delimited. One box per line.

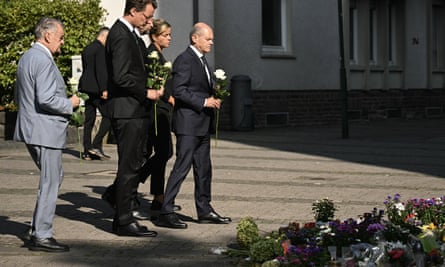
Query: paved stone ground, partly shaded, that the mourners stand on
xmin=0 ymin=119 xmax=445 ymax=267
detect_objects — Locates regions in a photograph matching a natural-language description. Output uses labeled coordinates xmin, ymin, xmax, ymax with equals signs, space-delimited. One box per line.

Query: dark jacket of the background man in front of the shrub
xmin=79 ymin=39 xmax=108 ymax=95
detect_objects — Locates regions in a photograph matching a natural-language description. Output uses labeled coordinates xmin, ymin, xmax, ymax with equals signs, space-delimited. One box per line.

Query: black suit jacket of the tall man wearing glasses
xmin=105 ymin=20 xmax=151 ymax=119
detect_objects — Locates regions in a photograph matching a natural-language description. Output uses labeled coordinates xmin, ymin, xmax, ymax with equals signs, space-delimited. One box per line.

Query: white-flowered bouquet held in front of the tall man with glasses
xmin=146 ymin=51 xmax=172 ymax=135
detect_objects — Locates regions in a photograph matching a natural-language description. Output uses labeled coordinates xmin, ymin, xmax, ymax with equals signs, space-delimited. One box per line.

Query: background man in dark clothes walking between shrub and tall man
xmin=79 ymin=27 xmax=111 ymax=160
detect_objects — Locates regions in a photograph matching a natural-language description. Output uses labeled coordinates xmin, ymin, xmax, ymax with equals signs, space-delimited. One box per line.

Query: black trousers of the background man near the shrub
xmin=83 ymin=94 xmax=111 ymax=153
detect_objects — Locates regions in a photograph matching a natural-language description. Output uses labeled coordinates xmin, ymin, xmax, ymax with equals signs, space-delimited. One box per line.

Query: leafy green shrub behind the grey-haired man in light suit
xmin=0 ymin=0 xmax=106 ymax=107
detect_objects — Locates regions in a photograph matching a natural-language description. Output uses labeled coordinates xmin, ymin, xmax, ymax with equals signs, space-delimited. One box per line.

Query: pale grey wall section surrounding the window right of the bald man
xmin=215 ymin=0 xmax=340 ymax=90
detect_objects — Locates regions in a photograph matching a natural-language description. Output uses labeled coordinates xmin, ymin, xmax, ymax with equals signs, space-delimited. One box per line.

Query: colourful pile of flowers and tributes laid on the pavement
xmin=228 ymin=194 xmax=445 ymax=267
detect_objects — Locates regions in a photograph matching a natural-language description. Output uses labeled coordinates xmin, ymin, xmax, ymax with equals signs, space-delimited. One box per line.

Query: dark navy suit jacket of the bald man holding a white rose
xmin=173 ymin=47 xmax=215 ymax=136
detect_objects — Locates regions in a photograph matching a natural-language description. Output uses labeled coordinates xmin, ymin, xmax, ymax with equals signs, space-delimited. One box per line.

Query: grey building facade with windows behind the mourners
xmin=99 ymin=0 xmax=445 ymax=129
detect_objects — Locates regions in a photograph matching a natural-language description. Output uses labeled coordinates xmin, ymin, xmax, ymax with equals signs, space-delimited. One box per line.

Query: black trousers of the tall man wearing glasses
xmin=112 ymin=118 xmax=149 ymax=225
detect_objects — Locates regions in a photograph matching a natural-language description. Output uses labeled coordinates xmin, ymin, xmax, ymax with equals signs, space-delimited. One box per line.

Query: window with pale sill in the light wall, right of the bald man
xmin=261 ymin=0 xmax=294 ymax=58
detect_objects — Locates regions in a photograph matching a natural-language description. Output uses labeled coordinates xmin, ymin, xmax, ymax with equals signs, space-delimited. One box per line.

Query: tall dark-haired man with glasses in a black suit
xmin=106 ymin=0 xmax=163 ymax=237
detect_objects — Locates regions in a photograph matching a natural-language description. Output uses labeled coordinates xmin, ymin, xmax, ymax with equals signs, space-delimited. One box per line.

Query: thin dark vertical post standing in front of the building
xmin=338 ymin=0 xmax=349 ymax=139
